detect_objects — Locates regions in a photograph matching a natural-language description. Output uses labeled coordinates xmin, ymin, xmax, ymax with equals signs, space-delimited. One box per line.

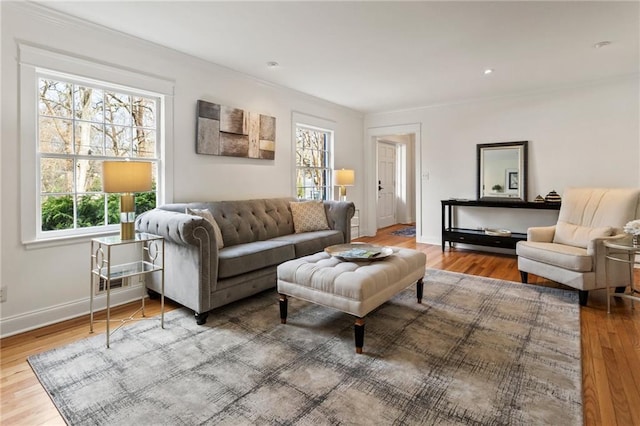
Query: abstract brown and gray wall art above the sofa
xmin=196 ymin=100 xmax=276 ymax=160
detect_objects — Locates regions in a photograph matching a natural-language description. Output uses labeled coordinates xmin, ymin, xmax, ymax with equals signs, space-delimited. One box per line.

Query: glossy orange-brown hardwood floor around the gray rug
xmin=0 ymin=225 xmax=640 ymax=426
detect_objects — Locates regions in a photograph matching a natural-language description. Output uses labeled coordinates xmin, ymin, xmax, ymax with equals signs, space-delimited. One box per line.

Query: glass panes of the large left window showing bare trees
xmin=37 ymin=77 xmax=158 ymax=231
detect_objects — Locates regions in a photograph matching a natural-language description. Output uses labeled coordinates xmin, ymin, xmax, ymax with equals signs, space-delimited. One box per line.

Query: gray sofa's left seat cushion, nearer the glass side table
xmin=218 ymin=240 xmax=295 ymax=278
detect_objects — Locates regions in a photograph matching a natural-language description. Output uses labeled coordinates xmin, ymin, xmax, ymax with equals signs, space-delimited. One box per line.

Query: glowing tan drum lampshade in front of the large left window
xmin=102 ymin=161 xmax=152 ymax=193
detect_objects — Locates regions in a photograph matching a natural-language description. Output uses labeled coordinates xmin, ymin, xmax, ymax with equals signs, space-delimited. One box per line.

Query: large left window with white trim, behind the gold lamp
xmin=18 ymin=43 xmax=175 ymax=247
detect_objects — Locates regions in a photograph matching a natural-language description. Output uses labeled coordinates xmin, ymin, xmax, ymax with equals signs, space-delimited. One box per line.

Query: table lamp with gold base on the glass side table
xmin=102 ymin=161 xmax=152 ymax=240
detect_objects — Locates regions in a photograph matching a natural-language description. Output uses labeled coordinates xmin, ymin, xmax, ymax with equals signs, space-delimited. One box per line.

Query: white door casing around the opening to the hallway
xmin=361 ymin=123 xmax=422 ymax=242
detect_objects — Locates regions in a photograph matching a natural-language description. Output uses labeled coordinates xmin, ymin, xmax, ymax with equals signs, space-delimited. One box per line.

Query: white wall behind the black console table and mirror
xmin=365 ymin=75 xmax=640 ymax=244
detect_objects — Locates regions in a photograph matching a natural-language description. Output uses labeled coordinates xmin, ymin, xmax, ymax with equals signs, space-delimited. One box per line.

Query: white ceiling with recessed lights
xmin=39 ymin=1 xmax=640 ymax=113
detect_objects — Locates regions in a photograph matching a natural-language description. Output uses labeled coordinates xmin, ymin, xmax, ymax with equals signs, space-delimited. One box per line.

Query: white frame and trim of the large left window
xmin=18 ymin=44 xmax=174 ymax=247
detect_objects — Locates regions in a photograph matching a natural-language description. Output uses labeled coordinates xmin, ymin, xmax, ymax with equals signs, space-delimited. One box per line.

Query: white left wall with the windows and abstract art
xmin=0 ymin=2 xmax=364 ymax=335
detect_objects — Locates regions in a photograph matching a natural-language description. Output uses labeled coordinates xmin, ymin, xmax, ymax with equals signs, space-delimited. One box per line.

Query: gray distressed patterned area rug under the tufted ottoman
xmin=29 ymin=270 xmax=582 ymax=425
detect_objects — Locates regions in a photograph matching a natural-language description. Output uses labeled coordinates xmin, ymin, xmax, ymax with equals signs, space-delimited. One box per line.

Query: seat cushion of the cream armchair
xmin=516 ymin=241 xmax=593 ymax=272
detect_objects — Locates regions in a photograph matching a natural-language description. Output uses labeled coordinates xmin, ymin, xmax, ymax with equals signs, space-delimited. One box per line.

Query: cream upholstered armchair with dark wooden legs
xmin=516 ymin=188 xmax=640 ymax=306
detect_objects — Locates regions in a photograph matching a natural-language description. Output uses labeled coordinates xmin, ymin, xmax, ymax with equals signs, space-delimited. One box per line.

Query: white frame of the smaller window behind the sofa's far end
xmin=291 ymin=112 xmax=336 ymax=200
